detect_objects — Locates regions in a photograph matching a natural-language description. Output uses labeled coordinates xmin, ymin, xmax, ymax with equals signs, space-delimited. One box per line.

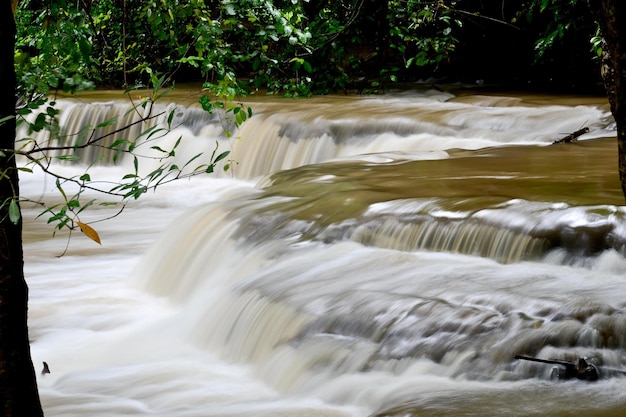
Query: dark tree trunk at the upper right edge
xmin=588 ymin=0 xmax=626 ymax=197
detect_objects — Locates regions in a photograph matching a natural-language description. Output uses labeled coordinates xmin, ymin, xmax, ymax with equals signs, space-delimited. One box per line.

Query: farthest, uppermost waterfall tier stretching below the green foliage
xmin=25 ymin=90 xmax=614 ymax=179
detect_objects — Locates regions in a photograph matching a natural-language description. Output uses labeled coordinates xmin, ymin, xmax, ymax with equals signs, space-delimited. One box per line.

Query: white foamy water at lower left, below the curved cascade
xmin=22 ymin=170 xmax=366 ymax=416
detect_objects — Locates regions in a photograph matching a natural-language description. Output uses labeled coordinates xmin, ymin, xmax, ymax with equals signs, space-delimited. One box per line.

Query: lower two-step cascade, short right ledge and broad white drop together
xmin=130 ymin=164 xmax=626 ymax=392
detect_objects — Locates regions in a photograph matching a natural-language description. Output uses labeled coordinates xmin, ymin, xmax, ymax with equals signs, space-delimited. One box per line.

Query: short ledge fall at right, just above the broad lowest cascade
xmin=351 ymin=201 xmax=626 ymax=263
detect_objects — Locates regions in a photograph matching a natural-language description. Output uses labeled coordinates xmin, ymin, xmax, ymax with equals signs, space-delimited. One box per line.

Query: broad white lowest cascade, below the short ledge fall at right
xmin=133 ymin=197 xmax=626 ymax=386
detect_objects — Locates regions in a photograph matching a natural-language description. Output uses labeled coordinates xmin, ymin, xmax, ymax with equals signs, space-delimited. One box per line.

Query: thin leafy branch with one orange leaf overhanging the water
xmin=10 ymin=70 xmax=239 ymax=249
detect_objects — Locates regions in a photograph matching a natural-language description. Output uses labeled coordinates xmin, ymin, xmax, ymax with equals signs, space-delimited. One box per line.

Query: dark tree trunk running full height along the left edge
xmin=0 ymin=0 xmax=43 ymax=417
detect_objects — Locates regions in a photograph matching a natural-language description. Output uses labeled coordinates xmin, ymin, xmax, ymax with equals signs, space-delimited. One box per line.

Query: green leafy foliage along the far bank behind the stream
xmin=16 ymin=0 xmax=597 ymax=96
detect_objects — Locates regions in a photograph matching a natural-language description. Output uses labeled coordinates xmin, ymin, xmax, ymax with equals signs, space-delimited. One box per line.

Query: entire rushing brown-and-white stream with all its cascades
xmin=22 ymin=86 xmax=626 ymax=417
